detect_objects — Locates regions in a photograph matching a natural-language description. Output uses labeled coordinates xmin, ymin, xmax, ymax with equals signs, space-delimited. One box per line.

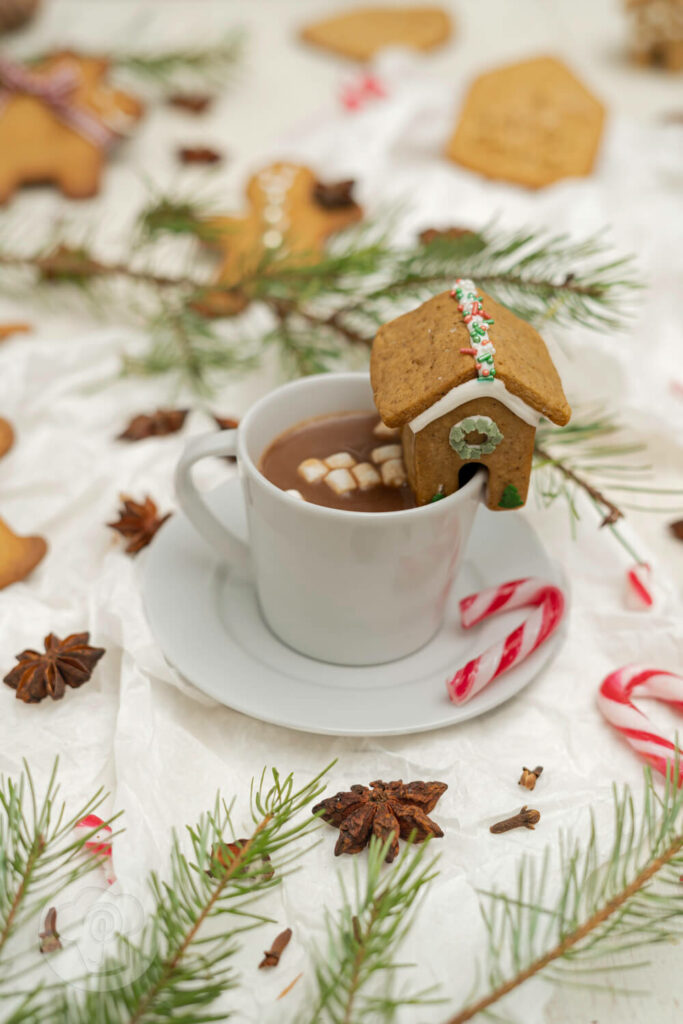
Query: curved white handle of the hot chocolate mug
xmin=175 ymin=430 xmax=252 ymax=580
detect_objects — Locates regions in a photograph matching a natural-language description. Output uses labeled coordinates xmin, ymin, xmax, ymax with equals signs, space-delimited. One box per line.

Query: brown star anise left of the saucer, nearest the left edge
xmin=3 ymin=633 xmax=104 ymax=703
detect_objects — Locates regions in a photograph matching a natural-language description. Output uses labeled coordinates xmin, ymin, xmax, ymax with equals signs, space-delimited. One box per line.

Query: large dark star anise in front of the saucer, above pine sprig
xmin=313 ymin=779 xmax=449 ymax=862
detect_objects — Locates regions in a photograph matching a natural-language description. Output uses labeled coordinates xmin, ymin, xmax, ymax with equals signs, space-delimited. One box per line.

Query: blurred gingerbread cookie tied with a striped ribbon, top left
xmin=0 ymin=52 xmax=142 ymax=203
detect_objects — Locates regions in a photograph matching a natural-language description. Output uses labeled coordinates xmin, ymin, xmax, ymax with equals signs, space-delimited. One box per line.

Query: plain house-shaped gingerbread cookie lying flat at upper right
xmin=445 ymin=57 xmax=605 ymax=188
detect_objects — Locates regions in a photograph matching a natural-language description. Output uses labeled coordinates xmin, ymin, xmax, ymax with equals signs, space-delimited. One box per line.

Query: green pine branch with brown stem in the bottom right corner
xmin=445 ymin=760 xmax=683 ymax=1024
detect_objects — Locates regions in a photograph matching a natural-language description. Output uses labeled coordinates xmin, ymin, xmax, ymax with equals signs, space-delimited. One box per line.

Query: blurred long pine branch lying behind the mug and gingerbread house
xmin=0 ymin=214 xmax=637 ymax=388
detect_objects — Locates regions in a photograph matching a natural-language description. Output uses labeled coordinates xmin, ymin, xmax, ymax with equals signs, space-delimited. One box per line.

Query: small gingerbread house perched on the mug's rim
xmin=371 ymin=280 xmax=571 ymax=509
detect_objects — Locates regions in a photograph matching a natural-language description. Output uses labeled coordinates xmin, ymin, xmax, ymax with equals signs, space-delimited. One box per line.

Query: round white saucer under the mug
xmin=143 ymin=478 xmax=566 ymax=736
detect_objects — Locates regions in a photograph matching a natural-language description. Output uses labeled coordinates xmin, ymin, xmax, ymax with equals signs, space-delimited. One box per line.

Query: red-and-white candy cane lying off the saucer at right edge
xmin=598 ymin=665 xmax=683 ymax=785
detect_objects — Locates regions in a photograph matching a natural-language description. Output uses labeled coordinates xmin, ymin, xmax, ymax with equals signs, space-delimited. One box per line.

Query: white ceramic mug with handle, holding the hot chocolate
xmin=176 ymin=373 xmax=485 ymax=665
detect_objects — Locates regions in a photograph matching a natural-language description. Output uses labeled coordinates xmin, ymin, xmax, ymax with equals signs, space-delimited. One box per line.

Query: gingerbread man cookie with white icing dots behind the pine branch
xmin=196 ymin=163 xmax=362 ymax=316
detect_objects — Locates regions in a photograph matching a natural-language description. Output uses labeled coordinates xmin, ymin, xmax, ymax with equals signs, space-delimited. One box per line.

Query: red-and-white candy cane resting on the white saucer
xmin=446 ymin=579 xmax=564 ymax=703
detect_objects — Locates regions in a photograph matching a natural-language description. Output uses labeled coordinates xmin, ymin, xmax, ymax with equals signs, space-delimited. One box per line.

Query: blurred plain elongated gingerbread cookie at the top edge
xmin=301 ymin=5 xmax=451 ymax=60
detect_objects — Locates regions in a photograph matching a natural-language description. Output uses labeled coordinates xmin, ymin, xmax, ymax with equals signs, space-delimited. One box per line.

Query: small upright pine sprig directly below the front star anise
xmin=309 ymin=838 xmax=436 ymax=1024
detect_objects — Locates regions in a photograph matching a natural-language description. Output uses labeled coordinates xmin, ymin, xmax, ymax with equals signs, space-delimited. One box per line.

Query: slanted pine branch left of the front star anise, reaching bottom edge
xmin=52 ymin=769 xmax=328 ymax=1024
